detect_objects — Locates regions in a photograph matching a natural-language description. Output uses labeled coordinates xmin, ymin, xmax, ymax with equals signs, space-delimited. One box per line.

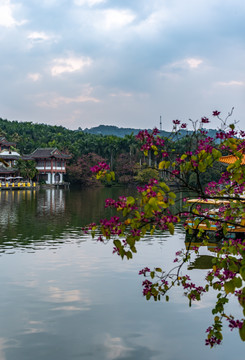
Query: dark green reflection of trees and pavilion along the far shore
xmin=0 ymin=188 xmax=136 ymax=248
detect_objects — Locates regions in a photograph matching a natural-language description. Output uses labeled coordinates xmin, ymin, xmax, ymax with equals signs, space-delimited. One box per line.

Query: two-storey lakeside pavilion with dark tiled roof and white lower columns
xmin=23 ymin=148 xmax=71 ymax=184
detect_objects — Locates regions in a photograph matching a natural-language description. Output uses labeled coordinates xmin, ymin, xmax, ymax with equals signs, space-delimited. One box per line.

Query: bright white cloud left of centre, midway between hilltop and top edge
xmin=51 ymin=57 xmax=92 ymax=76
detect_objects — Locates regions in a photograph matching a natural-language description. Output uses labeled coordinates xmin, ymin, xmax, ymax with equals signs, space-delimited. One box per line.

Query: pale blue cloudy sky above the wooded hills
xmin=0 ymin=0 xmax=245 ymax=130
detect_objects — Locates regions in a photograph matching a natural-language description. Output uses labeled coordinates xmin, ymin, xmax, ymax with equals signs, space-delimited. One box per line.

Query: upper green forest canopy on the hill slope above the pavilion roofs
xmin=0 ymin=118 xmax=139 ymax=160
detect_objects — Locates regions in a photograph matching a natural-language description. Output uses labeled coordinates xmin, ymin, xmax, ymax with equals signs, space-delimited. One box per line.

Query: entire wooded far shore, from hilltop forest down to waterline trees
xmin=0 ymin=118 xmax=219 ymax=185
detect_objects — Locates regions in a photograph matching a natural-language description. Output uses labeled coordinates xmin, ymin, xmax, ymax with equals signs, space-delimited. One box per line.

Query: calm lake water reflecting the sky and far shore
xmin=0 ymin=188 xmax=244 ymax=360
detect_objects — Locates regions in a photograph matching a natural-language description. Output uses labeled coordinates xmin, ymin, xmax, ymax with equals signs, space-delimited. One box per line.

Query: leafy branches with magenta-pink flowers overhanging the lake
xmin=84 ymin=108 xmax=245 ymax=347
